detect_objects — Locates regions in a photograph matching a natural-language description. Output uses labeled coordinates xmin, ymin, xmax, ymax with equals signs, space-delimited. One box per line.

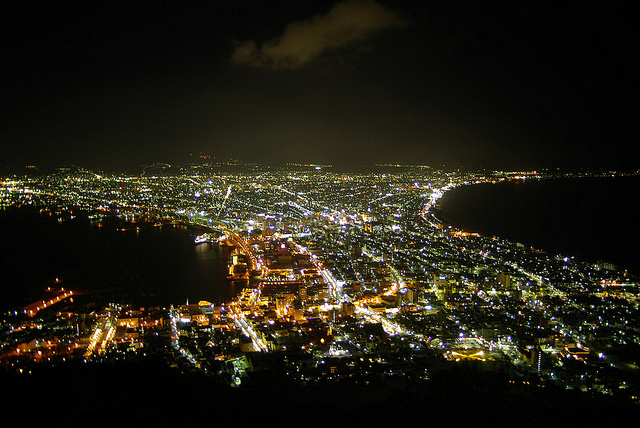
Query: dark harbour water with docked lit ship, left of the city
xmin=0 ymin=207 xmax=242 ymax=306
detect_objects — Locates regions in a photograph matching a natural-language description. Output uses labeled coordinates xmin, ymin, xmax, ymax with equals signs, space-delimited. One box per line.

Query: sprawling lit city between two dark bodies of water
xmin=0 ymin=165 xmax=640 ymax=400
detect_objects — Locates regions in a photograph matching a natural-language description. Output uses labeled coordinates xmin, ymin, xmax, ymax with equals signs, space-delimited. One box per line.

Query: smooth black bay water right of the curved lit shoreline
xmin=440 ymin=176 xmax=640 ymax=274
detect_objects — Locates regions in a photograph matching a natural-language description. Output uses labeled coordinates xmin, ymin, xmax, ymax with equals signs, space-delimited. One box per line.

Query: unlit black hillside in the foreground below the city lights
xmin=1 ymin=363 xmax=640 ymax=428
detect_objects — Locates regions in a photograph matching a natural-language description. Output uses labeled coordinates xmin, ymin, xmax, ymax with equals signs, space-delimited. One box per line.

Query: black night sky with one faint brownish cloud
xmin=0 ymin=0 xmax=640 ymax=169
